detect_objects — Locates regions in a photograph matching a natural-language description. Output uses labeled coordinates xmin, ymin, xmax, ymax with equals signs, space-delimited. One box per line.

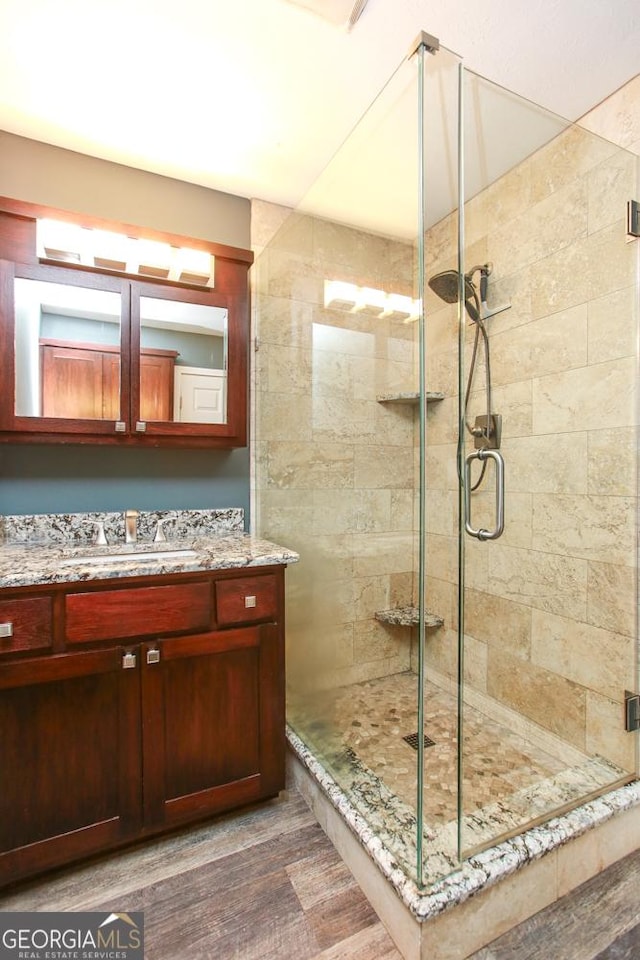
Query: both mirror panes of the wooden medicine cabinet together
xmin=14 ymin=277 xmax=228 ymax=424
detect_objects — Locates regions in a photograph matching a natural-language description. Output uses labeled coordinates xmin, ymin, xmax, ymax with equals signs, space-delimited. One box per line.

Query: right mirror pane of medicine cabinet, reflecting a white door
xmin=140 ymin=297 xmax=228 ymax=423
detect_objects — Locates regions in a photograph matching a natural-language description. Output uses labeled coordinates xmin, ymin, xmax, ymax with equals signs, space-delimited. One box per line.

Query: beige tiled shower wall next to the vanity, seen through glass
xmin=253 ymin=202 xmax=415 ymax=692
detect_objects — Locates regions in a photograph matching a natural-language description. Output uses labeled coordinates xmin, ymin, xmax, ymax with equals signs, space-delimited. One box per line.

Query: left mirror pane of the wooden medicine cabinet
xmin=14 ymin=278 xmax=120 ymax=420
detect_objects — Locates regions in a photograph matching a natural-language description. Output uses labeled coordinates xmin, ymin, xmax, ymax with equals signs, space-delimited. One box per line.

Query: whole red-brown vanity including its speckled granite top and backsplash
xmin=0 ymin=510 xmax=298 ymax=885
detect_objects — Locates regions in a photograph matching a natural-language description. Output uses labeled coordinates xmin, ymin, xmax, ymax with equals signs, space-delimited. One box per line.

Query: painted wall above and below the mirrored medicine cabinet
xmin=0 ymin=131 xmax=251 ymax=518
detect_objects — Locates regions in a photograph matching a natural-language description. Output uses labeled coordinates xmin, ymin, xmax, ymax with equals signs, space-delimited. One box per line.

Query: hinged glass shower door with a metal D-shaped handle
xmin=460 ymin=71 xmax=638 ymax=857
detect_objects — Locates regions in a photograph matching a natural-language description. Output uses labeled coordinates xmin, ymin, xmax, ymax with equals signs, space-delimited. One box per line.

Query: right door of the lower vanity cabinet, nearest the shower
xmin=142 ymin=624 xmax=285 ymax=828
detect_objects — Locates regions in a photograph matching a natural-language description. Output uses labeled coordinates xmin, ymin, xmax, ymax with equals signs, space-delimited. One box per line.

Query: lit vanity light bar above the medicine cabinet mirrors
xmin=36 ymin=219 xmax=215 ymax=287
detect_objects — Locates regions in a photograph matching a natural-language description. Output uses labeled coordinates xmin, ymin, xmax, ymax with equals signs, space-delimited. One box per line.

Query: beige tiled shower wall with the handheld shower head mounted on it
xmin=420 ymin=86 xmax=638 ymax=770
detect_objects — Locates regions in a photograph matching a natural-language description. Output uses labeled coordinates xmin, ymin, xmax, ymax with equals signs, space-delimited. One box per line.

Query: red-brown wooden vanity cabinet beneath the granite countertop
xmin=0 ymin=566 xmax=285 ymax=885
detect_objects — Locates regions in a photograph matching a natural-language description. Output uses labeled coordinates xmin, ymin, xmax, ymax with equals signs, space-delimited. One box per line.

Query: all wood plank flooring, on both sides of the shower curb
xmin=0 ymin=789 xmax=640 ymax=960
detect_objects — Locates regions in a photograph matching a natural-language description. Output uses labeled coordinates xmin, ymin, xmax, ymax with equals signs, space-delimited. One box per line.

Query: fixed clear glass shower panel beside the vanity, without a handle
xmin=254 ymin=39 xmax=464 ymax=880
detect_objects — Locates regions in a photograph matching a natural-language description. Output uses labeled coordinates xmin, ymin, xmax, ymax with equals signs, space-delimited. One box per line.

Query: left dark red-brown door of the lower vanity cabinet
xmin=0 ymin=648 xmax=141 ymax=883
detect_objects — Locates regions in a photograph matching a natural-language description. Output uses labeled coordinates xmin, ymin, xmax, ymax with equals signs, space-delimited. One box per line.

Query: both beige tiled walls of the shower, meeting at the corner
xmin=253 ymin=80 xmax=640 ymax=770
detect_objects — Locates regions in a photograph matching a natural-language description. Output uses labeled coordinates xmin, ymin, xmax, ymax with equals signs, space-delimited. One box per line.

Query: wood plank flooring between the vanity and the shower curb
xmin=0 ymin=790 xmax=402 ymax=960
